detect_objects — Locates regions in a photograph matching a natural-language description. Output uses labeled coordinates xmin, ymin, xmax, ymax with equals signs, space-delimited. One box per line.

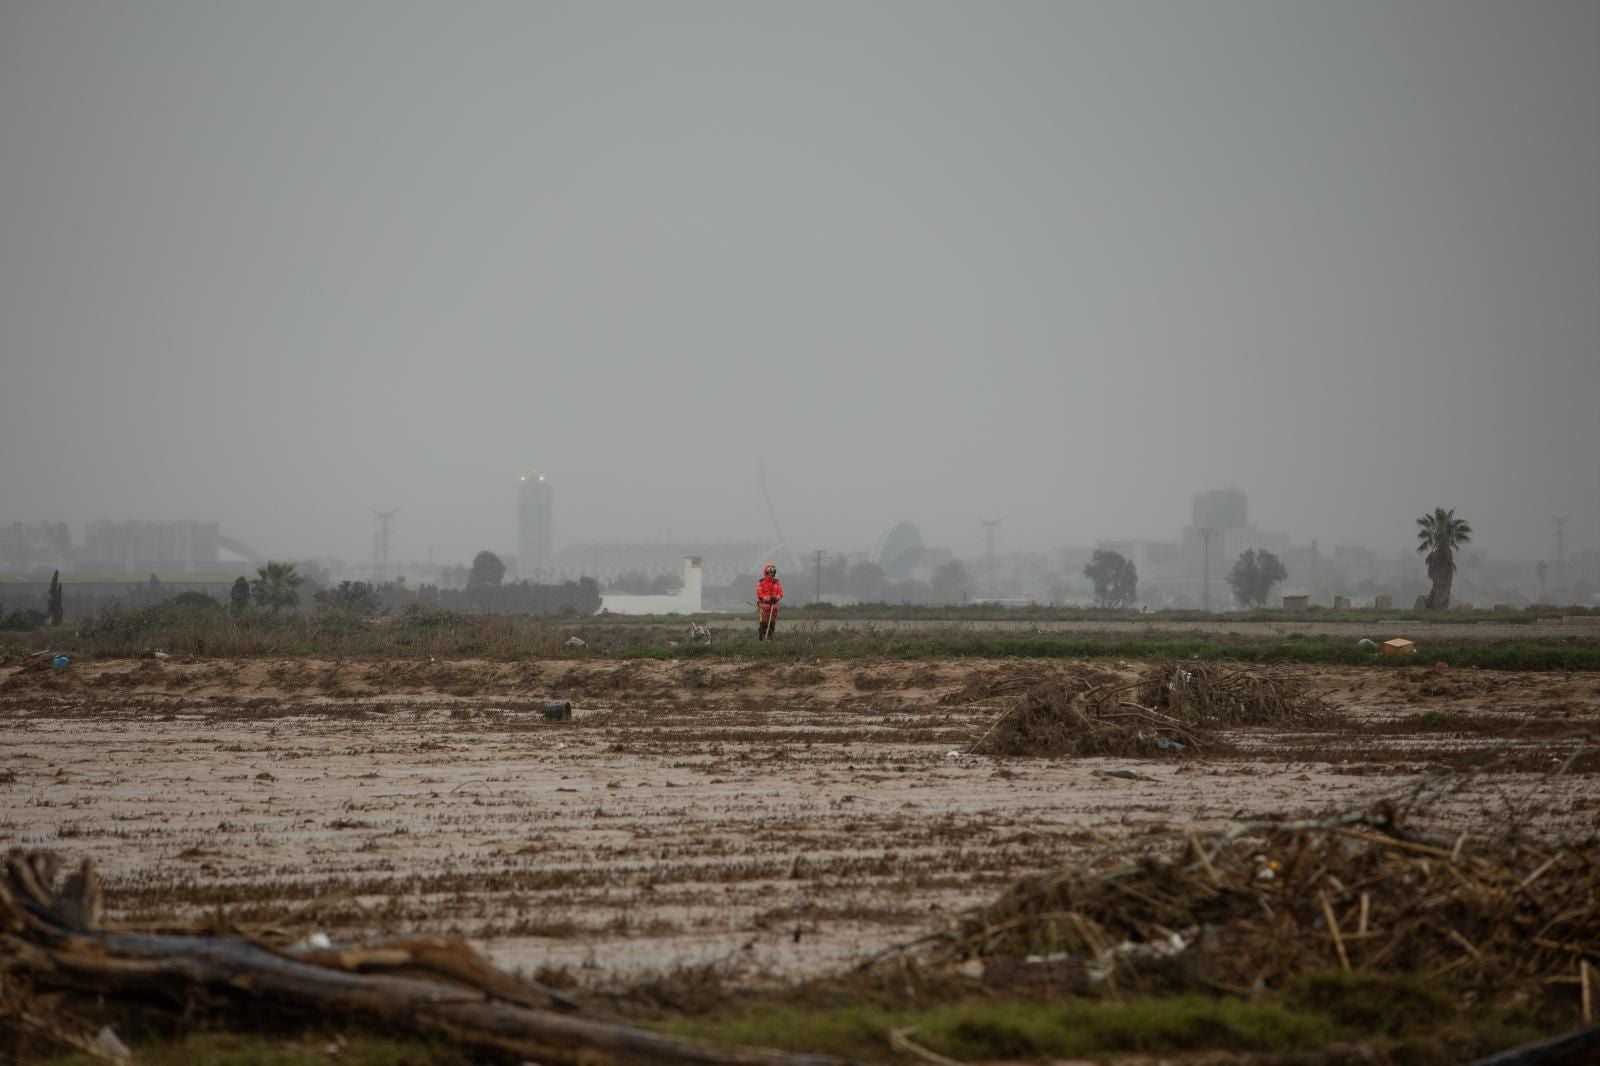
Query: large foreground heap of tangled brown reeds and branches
xmin=915 ymin=807 xmax=1600 ymax=1020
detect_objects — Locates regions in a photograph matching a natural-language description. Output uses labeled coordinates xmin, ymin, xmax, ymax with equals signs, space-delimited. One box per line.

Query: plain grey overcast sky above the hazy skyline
xmin=0 ymin=0 xmax=1600 ymax=560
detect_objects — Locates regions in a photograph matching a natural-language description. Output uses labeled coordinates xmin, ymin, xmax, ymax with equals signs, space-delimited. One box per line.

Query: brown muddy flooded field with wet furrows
xmin=0 ymin=658 xmax=1600 ymax=978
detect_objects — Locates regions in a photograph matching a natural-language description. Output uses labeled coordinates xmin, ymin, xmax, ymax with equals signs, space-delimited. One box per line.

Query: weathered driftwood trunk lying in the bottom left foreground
xmin=0 ymin=850 xmax=837 ymax=1066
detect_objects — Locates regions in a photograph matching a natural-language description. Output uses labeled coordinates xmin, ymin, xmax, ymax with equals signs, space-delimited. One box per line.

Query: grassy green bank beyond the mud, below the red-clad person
xmin=9 ymin=603 xmax=1600 ymax=671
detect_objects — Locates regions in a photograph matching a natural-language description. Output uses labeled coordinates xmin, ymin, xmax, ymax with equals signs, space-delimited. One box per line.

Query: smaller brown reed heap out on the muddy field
xmin=973 ymin=663 xmax=1328 ymax=755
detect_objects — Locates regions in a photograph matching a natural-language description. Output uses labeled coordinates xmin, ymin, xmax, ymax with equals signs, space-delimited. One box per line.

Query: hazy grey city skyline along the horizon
xmin=0 ymin=499 xmax=1600 ymax=610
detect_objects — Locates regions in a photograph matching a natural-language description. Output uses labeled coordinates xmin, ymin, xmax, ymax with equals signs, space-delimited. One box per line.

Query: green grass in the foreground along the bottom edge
xmin=31 ymin=973 xmax=1565 ymax=1066
